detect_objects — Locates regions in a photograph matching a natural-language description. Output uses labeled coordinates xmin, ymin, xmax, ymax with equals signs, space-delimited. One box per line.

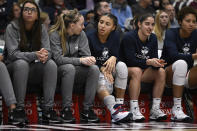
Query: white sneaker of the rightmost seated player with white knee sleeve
xmin=171 ymin=107 xmax=191 ymax=122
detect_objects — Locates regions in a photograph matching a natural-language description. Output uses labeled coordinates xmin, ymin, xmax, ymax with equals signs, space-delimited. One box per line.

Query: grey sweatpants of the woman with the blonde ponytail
xmin=58 ymin=64 xmax=100 ymax=109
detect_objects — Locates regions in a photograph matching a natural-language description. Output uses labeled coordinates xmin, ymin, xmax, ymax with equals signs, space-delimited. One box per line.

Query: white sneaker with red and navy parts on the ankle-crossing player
xmin=111 ymin=104 xmax=132 ymax=122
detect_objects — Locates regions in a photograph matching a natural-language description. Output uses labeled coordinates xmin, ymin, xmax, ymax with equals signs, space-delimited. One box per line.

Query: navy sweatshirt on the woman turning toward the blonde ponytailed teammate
xmin=87 ymin=30 xmax=120 ymax=67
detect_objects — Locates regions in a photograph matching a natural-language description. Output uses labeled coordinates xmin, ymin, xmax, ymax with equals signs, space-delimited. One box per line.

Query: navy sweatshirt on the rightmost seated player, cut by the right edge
xmin=162 ymin=28 xmax=197 ymax=68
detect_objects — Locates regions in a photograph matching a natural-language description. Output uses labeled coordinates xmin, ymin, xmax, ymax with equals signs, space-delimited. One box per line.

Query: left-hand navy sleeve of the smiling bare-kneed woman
xmin=121 ymin=34 xmax=147 ymax=69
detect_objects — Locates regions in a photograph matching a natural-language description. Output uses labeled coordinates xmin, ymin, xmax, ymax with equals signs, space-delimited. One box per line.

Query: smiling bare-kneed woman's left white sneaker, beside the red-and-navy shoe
xmin=130 ymin=107 xmax=145 ymax=122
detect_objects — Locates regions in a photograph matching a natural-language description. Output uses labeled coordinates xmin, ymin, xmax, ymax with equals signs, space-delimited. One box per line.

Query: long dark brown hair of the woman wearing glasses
xmin=19 ymin=0 xmax=42 ymax=51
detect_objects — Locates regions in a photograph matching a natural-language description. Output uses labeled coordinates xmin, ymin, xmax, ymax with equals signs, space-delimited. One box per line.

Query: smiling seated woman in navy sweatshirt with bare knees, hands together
xmin=121 ymin=14 xmax=167 ymax=121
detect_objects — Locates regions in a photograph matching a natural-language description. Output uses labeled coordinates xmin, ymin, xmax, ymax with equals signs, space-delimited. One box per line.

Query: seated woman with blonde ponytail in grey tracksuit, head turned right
xmin=49 ymin=10 xmax=99 ymax=123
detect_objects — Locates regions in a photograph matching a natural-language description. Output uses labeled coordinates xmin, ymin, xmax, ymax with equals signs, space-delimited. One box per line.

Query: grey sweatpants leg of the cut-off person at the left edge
xmin=0 ymin=61 xmax=16 ymax=106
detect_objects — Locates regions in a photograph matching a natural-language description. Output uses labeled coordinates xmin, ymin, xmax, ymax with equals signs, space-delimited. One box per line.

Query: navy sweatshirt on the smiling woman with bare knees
xmin=120 ymin=30 xmax=158 ymax=69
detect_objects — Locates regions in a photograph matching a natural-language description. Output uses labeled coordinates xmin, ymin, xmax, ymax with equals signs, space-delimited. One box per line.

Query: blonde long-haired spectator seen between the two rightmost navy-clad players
xmin=154 ymin=10 xmax=170 ymax=58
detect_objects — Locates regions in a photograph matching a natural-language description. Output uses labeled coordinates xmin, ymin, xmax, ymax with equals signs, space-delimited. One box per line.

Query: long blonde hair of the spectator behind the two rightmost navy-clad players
xmin=154 ymin=10 xmax=170 ymax=41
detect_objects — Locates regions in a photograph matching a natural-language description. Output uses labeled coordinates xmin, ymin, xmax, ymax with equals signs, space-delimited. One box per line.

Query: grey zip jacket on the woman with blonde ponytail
xmin=49 ymin=31 xmax=91 ymax=66
